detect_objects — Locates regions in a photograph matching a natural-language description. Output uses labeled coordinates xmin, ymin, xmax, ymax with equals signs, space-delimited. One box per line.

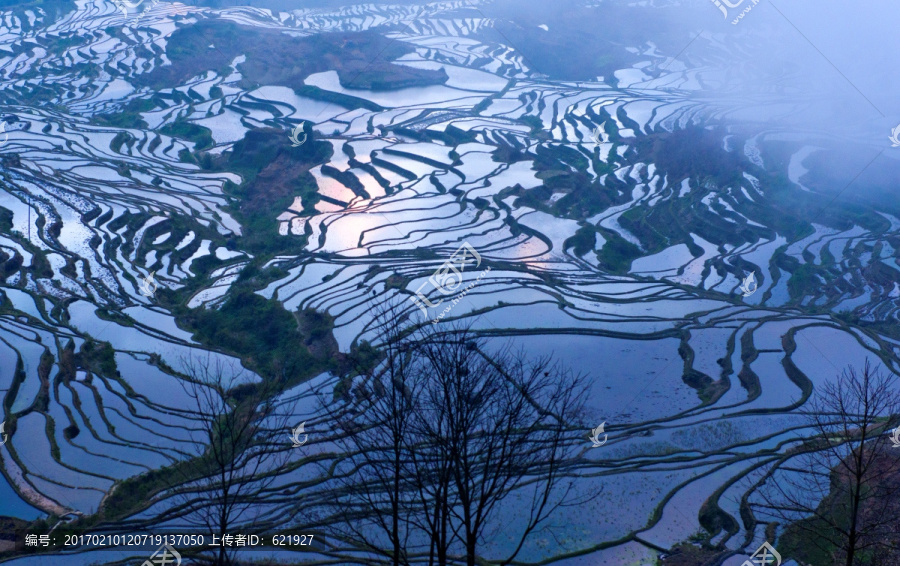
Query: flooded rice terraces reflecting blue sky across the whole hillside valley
xmin=0 ymin=0 xmax=900 ymax=565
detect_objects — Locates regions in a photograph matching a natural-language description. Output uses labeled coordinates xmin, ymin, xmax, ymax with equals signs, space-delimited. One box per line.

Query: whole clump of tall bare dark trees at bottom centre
xmin=332 ymin=313 xmax=585 ymax=565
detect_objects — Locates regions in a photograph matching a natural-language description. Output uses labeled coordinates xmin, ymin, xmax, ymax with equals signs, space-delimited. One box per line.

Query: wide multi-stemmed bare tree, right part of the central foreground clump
xmin=414 ymin=329 xmax=586 ymax=566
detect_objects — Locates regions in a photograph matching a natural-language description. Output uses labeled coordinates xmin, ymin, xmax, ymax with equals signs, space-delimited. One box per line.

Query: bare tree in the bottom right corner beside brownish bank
xmin=758 ymin=360 xmax=900 ymax=566
